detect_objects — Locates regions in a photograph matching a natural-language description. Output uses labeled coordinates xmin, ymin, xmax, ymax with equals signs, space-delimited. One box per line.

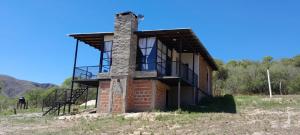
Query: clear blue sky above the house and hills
xmin=0 ymin=0 xmax=300 ymax=84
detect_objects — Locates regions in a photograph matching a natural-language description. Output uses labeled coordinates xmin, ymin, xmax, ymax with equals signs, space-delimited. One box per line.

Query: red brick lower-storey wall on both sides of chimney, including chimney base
xmin=97 ymin=80 xmax=169 ymax=113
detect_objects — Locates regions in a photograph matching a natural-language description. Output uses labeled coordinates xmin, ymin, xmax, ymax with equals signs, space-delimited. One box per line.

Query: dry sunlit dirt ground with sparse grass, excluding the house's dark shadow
xmin=0 ymin=96 xmax=300 ymax=135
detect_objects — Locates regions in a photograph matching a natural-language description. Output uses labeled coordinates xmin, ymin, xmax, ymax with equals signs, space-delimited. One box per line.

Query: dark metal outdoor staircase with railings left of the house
xmin=42 ymin=87 xmax=88 ymax=115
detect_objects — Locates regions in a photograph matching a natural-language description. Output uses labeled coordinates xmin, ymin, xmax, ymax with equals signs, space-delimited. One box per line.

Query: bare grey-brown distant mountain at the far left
xmin=0 ymin=74 xmax=56 ymax=97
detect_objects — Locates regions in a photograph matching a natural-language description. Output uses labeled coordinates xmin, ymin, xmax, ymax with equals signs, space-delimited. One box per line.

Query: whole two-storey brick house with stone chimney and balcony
xmin=69 ymin=12 xmax=217 ymax=113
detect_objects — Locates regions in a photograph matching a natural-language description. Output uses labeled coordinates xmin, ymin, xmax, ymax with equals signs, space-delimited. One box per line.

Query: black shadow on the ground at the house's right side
xmin=178 ymin=95 xmax=236 ymax=113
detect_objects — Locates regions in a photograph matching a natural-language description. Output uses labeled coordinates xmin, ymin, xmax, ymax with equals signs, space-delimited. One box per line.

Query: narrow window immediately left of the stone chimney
xmin=101 ymin=41 xmax=112 ymax=72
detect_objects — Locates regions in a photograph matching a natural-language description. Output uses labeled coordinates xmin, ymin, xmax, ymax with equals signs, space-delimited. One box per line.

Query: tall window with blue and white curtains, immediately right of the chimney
xmin=136 ymin=37 xmax=156 ymax=71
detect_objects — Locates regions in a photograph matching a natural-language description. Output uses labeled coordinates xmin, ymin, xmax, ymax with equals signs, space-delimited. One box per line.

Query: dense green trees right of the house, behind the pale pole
xmin=213 ymin=55 xmax=300 ymax=94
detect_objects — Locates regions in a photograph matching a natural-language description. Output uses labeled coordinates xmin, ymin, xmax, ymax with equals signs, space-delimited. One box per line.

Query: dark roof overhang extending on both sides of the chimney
xmin=69 ymin=28 xmax=218 ymax=70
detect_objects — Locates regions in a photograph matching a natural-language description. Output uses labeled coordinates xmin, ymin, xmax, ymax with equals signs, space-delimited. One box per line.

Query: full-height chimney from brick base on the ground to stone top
xmin=108 ymin=12 xmax=138 ymax=113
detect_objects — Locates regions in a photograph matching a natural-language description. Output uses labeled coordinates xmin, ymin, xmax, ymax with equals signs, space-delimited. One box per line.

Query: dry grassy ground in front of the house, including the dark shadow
xmin=0 ymin=95 xmax=300 ymax=135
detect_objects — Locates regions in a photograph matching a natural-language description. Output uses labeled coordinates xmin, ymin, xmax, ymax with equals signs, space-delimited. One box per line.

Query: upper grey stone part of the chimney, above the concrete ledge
xmin=110 ymin=11 xmax=138 ymax=76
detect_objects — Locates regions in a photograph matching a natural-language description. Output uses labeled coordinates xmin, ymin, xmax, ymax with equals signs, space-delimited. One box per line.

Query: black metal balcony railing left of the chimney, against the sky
xmin=74 ymin=66 xmax=99 ymax=80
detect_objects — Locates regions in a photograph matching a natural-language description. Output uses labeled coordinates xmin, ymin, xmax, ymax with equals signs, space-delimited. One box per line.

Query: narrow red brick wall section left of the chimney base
xmin=97 ymin=81 xmax=110 ymax=112
